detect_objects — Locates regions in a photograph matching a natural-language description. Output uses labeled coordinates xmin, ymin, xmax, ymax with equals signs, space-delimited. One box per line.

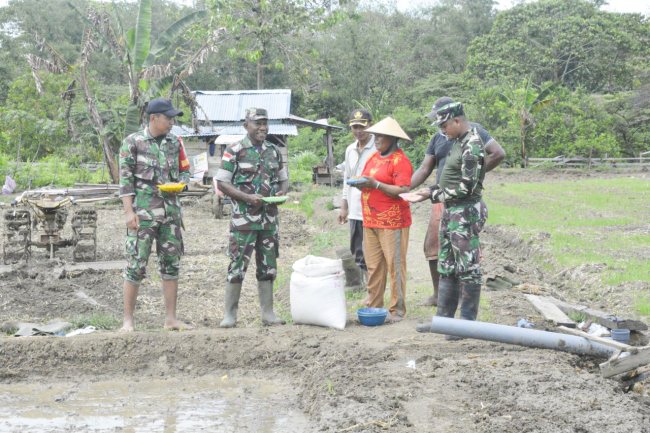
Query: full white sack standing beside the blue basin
xmin=289 ymin=256 xmax=347 ymax=330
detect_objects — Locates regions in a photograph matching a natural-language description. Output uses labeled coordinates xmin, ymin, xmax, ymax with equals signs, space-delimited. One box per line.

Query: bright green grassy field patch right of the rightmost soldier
xmin=485 ymin=178 xmax=650 ymax=285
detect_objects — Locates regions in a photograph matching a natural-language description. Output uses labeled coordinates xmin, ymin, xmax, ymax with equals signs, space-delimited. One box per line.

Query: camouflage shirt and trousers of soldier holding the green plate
xmin=216 ymin=136 xmax=287 ymax=283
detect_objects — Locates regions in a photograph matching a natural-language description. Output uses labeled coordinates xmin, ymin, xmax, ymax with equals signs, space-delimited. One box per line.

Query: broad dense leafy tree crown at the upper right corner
xmin=467 ymin=0 xmax=650 ymax=91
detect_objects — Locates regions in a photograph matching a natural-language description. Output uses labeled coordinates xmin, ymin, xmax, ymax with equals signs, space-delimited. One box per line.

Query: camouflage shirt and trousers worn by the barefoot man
xmin=120 ymin=129 xmax=189 ymax=284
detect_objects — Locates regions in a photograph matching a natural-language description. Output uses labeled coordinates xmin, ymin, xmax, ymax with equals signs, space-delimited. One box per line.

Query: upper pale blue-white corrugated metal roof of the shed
xmin=194 ymin=89 xmax=291 ymax=122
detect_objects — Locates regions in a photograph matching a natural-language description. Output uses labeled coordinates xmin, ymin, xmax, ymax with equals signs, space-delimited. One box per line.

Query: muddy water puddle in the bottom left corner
xmin=0 ymin=376 xmax=311 ymax=433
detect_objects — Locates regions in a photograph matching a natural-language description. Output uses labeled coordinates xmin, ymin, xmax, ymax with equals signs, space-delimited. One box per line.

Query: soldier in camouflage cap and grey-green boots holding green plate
xmin=216 ymin=108 xmax=289 ymax=328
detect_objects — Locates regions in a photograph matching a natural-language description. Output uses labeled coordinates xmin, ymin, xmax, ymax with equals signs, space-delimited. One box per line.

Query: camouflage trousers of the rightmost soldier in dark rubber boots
xmin=438 ymin=201 xmax=488 ymax=284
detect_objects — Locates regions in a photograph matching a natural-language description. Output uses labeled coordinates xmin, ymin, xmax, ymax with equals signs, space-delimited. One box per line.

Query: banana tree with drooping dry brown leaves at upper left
xmin=28 ymin=0 xmax=216 ymax=183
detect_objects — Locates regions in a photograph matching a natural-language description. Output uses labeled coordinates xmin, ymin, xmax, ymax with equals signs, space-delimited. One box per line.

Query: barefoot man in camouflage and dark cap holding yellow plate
xmin=119 ymin=98 xmax=192 ymax=332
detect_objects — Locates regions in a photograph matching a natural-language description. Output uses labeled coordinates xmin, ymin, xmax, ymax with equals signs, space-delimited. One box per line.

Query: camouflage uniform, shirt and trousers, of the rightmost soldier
xmin=432 ymin=128 xmax=487 ymax=284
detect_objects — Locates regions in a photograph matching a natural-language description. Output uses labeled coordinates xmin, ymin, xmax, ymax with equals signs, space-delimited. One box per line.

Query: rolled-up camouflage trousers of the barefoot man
xmin=124 ymin=216 xmax=183 ymax=284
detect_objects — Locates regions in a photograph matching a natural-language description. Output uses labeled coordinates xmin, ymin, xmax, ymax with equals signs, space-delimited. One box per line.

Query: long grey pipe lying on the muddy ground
xmin=418 ymin=316 xmax=618 ymax=358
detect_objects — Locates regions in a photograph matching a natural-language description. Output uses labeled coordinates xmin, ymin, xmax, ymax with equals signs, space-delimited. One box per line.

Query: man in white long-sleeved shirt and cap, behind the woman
xmin=338 ymin=108 xmax=375 ymax=287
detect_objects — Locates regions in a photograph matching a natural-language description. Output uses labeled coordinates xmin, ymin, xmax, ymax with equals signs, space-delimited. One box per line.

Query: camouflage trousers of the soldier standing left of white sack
xmin=228 ymin=229 xmax=279 ymax=283
